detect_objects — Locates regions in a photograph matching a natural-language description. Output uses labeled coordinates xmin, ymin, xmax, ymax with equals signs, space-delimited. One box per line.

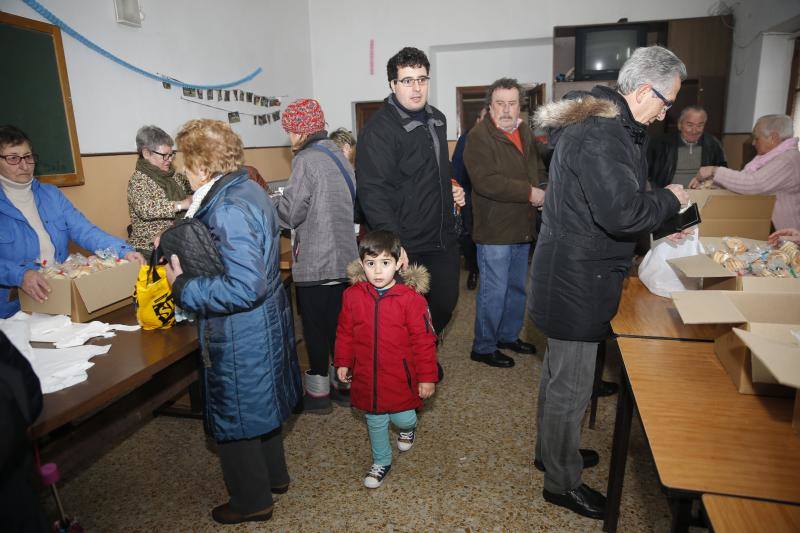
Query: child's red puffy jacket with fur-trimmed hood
xmin=333 ymin=261 xmax=438 ymax=413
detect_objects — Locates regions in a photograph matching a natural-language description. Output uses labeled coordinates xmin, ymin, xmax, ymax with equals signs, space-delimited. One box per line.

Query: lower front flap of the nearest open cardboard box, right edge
xmin=733 ymin=328 xmax=800 ymax=388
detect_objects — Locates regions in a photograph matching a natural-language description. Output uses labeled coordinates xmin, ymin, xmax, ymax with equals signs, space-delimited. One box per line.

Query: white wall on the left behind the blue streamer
xmin=0 ymin=0 xmax=312 ymax=153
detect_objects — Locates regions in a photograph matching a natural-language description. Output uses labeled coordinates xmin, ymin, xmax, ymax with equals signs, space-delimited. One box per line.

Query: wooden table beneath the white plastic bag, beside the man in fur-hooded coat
xmin=611 ymin=278 xmax=730 ymax=341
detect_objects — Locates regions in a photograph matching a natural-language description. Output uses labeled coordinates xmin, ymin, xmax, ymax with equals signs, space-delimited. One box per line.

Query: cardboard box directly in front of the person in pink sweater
xmin=686 ymin=189 xmax=775 ymax=240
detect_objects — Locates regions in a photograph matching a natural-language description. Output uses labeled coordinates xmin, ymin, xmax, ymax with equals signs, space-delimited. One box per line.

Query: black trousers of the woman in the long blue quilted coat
xmin=217 ymin=428 xmax=289 ymax=514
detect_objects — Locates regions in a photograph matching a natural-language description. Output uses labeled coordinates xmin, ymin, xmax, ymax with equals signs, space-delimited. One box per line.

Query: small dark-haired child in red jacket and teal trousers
xmin=333 ymin=231 xmax=439 ymax=489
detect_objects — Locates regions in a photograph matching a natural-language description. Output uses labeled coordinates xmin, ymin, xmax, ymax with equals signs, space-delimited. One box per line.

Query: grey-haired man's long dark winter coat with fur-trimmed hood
xmin=528 ymin=86 xmax=680 ymax=342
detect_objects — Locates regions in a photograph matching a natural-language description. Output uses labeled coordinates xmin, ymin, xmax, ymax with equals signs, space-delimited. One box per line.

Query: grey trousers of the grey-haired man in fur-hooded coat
xmin=536 ymin=338 xmax=598 ymax=493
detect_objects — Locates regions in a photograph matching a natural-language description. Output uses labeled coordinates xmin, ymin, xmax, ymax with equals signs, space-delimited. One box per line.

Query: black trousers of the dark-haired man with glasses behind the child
xmin=407 ymin=246 xmax=461 ymax=335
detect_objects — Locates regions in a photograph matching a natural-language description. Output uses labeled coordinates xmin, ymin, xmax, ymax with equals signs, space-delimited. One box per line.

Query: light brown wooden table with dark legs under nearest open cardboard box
xmin=604 ymin=338 xmax=800 ymax=531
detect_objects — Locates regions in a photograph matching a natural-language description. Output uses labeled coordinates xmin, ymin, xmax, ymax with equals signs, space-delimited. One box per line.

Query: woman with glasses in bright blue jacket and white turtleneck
xmin=0 ymin=125 xmax=144 ymax=318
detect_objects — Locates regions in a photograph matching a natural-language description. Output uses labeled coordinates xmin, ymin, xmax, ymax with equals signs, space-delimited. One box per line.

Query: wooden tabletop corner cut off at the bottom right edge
xmin=703 ymin=494 xmax=800 ymax=533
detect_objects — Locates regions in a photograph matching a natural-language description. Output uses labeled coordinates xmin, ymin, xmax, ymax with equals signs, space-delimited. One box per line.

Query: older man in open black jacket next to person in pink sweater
xmin=647 ymin=105 xmax=728 ymax=187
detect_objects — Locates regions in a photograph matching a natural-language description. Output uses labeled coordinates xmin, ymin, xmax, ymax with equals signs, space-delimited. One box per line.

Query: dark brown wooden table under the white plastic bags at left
xmin=32 ymin=305 xmax=199 ymax=437
